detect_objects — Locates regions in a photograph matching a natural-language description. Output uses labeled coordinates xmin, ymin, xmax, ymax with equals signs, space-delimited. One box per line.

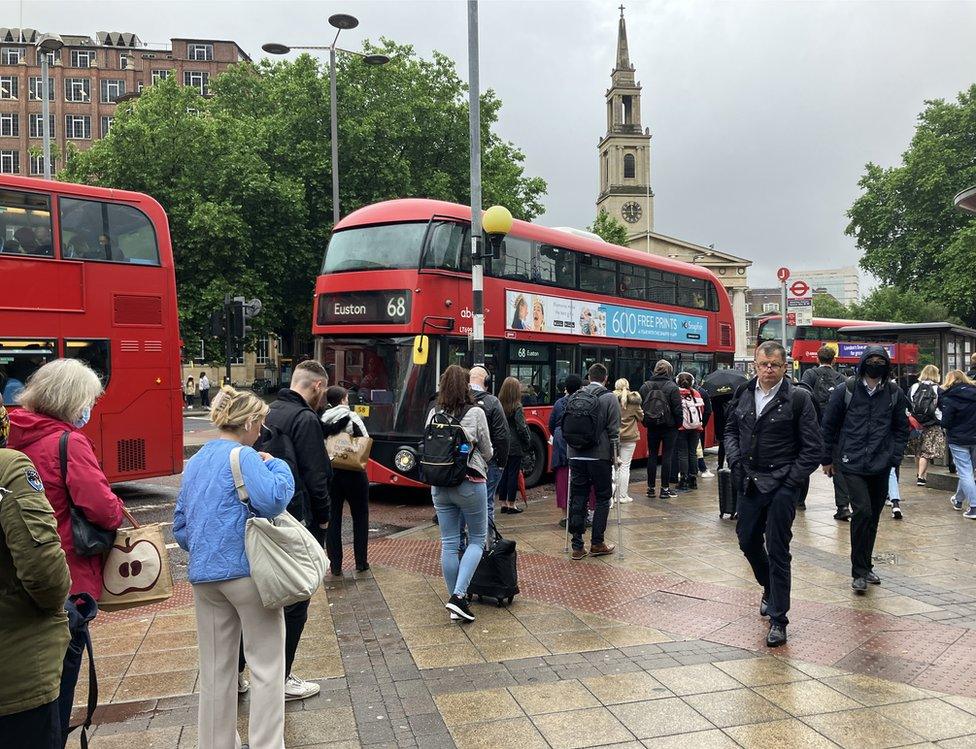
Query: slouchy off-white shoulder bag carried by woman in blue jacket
xmin=230 ymin=447 xmax=328 ymax=609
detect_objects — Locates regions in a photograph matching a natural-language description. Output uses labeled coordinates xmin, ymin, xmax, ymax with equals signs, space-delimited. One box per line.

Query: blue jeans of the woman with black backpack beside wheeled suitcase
xmin=430 ymin=480 xmax=488 ymax=596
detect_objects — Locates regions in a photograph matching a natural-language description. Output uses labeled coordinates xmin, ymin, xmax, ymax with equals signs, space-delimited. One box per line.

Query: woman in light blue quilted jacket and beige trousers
xmin=173 ymin=387 xmax=295 ymax=749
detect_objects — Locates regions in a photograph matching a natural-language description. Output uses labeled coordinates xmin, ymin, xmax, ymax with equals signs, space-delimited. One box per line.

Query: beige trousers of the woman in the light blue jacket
xmin=193 ymin=577 xmax=285 ymax=749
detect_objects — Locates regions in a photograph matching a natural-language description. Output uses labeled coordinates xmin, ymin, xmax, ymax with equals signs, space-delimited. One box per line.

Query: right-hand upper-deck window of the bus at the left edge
xmin=58 ymin=198 xmax=159 ymax=265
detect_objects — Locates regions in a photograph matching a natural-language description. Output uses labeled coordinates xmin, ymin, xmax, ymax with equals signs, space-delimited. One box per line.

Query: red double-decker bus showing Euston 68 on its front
xmin=312 ymin=199 xmax=734 ymax=487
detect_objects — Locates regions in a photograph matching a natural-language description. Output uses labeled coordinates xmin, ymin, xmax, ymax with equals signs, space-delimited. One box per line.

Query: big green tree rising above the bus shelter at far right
xmin=847 ymin=85 xmax=976 ymax=325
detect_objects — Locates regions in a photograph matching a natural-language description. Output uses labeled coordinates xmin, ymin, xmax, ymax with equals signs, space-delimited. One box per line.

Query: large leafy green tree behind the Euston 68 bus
xmin=60 ymin=41 xmax=546 ymax=356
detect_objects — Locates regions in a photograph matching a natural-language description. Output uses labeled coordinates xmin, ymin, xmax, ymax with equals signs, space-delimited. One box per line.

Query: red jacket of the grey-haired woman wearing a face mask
xmin=8 ymin=408 xmax=123 ymax=600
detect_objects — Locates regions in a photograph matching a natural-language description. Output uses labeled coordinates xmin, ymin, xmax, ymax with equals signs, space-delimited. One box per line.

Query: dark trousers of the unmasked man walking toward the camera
xmin=735 ymin=485 xmax=797 ymax=627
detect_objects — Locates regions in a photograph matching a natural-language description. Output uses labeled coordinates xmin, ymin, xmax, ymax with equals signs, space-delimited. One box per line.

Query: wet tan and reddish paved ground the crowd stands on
xmin=72 ymin=464 xmax=976 ymax=749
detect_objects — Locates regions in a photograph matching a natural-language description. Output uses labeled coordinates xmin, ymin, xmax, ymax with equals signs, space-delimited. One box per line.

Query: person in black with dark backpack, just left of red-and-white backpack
xmin=639 ymin=359 xmax=681 ymax=499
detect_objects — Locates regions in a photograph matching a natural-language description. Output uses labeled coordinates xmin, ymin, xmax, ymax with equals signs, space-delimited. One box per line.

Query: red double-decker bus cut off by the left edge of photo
xmin=0 ymin=175 xmax=183 ymax=482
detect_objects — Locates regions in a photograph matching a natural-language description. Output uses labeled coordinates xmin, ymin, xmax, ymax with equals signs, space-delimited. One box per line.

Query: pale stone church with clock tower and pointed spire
xmin=596 ymin=6 xmax=752 ymax=357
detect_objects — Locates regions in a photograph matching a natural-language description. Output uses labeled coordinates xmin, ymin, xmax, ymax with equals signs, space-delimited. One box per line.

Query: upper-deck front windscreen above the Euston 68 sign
xmin=322 ymin=223 xmax=427 ymax=273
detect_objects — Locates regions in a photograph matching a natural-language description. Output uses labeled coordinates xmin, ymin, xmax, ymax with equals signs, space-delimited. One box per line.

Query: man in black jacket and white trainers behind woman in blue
xmin=256 ymin=360 xmax=334 ymax=700
